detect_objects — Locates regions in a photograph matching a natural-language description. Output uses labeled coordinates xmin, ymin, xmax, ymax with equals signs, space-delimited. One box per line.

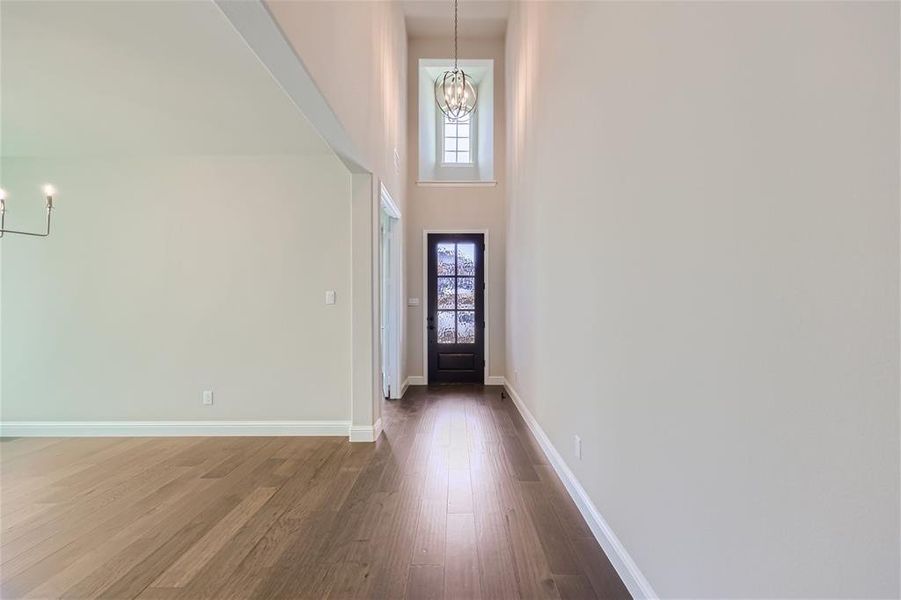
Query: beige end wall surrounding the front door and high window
xmin=406 ymin=39 xmax=506 ymax=377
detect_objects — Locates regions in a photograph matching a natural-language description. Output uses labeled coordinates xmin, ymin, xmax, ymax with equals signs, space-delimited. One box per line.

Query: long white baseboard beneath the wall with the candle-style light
xmin=0 ymin=421 xmax=350 ymax=437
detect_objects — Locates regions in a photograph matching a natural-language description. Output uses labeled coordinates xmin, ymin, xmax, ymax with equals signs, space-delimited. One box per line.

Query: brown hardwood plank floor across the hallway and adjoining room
xmin=0 ymin=386 xmax=628 ymax=600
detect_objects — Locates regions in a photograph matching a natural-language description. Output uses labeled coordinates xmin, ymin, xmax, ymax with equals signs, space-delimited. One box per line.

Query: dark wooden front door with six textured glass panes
xmin=427 ymin=233 xmax=485 ymax=383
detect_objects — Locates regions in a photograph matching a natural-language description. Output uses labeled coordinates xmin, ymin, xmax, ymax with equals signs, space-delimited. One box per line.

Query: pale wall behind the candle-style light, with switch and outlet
xmin=0 ymin=155 xmax=351 ymax=422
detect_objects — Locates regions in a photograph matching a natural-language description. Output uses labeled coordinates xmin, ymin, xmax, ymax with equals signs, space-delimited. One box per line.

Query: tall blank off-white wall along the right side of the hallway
xmin=507 ymin=2 xmax=901 ymax=598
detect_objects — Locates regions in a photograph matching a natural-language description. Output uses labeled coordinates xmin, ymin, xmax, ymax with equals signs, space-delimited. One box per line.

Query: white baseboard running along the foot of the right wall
xmin=504 ymin=380 xmax=658 ymax=598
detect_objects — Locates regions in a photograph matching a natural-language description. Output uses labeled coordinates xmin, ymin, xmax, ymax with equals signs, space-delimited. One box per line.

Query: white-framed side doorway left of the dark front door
xmin=375 ymin=181 xmax=403 ymax=400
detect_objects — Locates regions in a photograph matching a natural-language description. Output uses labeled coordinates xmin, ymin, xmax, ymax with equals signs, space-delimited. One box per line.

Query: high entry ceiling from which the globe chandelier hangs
xmin=401 ymin=0 xmax=510 ymax=38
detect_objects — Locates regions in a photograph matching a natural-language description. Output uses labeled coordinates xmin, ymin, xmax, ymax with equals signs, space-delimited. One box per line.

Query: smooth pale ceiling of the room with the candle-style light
xmin=0 ymin=0 xmax=329 ymax=156
